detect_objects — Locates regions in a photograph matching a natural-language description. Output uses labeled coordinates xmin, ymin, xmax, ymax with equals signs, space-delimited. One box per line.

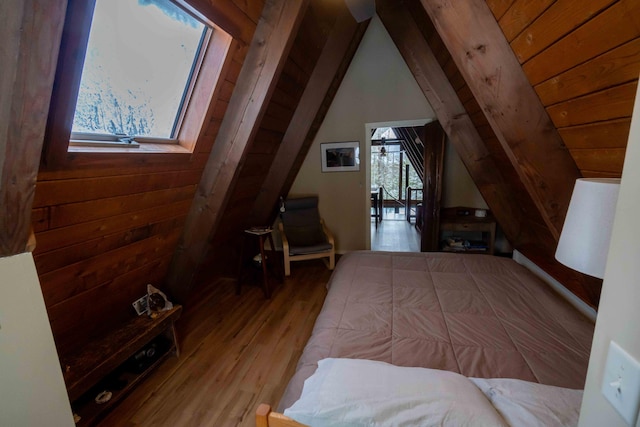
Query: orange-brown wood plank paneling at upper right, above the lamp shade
xmin=489 ymin=0 xmax=640 ymax=177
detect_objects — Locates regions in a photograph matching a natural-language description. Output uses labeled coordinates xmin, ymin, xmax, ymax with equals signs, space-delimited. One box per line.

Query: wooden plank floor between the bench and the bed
xmin=99 ymin=260 xmax=331 ymax=427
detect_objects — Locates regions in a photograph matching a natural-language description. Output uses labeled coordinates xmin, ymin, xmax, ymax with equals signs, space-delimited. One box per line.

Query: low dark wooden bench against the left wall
xmin=62 ymin=305 xmax=182 ymax=425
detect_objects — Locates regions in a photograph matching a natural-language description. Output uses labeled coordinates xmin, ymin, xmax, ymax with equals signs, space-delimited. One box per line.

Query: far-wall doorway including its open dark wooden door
xmin=367 ymin=121 xmax=446 ymax=252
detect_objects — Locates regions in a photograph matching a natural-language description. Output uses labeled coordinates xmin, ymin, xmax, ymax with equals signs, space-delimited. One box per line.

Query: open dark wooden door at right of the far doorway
xmin=420 ymin=121 xmax=445 ymax=252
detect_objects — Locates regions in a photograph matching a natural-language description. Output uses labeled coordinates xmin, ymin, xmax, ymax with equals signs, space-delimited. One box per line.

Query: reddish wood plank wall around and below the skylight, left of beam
xmin=32 ymin=0 xmax=263 ymax=357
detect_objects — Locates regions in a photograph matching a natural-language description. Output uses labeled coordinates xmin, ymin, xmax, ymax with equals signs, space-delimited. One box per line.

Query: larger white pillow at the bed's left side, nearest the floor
xmin=284 ymin=359 xmax=507 ymax=427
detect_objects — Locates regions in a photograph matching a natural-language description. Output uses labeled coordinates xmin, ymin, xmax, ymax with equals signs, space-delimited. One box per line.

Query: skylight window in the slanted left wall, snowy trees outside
xmin=71 ymin=0 xmax=212 ymax=143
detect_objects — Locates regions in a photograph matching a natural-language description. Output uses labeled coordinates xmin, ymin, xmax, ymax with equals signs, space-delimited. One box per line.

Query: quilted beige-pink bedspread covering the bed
xmin=279 ymin=251 xmax=594 ymax=411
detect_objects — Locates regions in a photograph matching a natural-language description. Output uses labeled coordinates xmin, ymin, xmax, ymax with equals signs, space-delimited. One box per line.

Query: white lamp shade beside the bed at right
xmin=556 ymin=178 xmax=620 ymax=279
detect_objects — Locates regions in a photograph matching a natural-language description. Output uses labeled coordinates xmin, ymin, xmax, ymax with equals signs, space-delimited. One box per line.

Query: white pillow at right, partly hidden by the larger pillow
xmin=470 ymin=378 xmax=582 ymax=427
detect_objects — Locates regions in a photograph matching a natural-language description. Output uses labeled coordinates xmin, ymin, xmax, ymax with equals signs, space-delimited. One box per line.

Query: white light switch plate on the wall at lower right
xmin=602 ymin=341 xmax=640 ymax=426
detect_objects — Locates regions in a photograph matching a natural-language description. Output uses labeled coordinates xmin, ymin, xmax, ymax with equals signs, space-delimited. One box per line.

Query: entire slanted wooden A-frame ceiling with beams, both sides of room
xmin=0 ymin=0 xmax=640 ymax=362
